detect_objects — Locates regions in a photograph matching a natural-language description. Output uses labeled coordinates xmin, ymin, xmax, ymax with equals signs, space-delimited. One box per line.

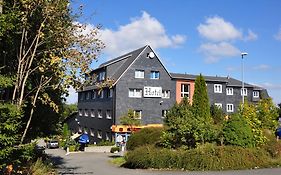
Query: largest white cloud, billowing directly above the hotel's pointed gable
xmin=97 ymin=11 xmax=186 ymax=56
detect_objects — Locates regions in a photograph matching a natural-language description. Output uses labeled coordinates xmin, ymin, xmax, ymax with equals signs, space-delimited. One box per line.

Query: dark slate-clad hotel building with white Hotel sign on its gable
xmin=71 ymin=46 xmax=267 ymax=142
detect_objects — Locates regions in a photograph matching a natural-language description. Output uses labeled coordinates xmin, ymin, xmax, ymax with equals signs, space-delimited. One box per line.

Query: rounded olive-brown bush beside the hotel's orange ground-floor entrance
xmin=126 ymin=127 xmax=163 ymax=150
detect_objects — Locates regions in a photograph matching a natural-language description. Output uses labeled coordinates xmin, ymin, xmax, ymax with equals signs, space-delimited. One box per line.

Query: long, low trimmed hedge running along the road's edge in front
xmin=125 ymin=146 xmax=271 ymax=170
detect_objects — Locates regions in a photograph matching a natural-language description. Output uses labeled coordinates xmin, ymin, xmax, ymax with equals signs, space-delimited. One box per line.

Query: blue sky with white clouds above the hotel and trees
xmin=65 ymin=0 xmax=281 ymax=103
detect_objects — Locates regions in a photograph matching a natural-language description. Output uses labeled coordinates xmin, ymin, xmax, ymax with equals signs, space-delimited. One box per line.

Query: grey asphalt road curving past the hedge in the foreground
xmin=46 ymin=149 xmax=281 ymax=175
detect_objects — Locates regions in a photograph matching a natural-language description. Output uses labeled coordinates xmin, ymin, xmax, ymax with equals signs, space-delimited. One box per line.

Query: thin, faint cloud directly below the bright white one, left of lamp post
xmin=199 ymin=42 xmax=240 ymax=63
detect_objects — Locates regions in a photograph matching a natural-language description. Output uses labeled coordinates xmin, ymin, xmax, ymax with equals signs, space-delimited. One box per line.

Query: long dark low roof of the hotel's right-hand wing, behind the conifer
xmin=171 ymin=73 xmax=263 ymax=90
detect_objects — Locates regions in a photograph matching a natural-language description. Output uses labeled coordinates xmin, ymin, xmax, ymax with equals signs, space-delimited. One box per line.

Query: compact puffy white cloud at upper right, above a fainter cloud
xmin=197 ymin=16 xmax=242 ymax=41
